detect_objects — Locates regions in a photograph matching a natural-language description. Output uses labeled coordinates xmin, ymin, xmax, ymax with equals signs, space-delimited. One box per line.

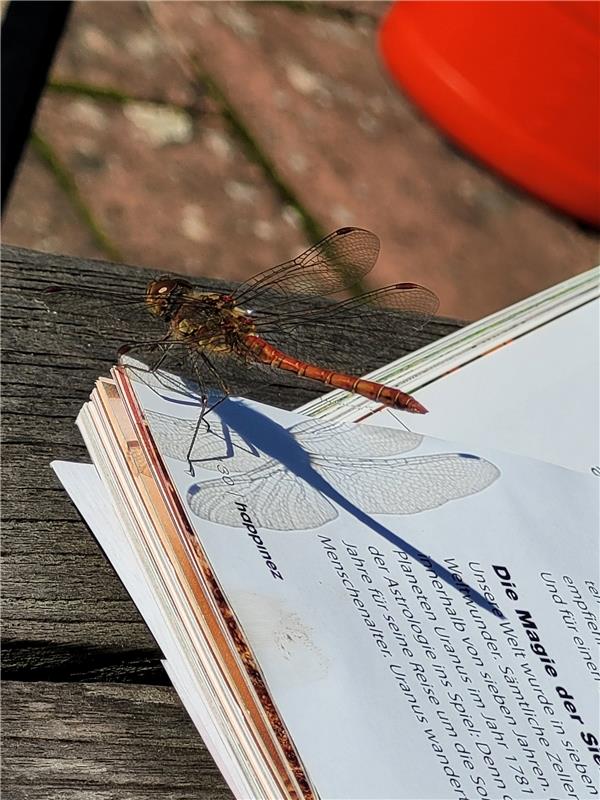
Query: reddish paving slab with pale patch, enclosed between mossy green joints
xmin=27 ymin=88 xmax=306 ymax=280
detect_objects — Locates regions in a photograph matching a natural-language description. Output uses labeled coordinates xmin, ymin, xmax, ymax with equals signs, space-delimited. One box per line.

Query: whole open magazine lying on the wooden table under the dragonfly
xmin=54 ymin=273 xmax=600 ymax=800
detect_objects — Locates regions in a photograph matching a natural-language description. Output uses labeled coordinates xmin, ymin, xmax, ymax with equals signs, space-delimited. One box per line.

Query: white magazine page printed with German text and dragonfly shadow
xmin=126 ymin=372 xmax=600 ymax=800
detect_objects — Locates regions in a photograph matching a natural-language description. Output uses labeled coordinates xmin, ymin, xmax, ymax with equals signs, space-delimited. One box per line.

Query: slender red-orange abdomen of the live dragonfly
xmin=245 ymin=335 xmax=427 ymax=414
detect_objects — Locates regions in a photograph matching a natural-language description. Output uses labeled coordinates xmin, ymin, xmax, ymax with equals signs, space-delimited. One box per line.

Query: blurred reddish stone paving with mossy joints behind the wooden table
xmin=3 ymin=1 xmax=598 ymax=319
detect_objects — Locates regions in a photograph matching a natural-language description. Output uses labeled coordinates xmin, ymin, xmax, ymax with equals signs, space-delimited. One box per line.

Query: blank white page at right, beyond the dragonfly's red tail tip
xmin=368 ymin=300 xmax=600 ymax=473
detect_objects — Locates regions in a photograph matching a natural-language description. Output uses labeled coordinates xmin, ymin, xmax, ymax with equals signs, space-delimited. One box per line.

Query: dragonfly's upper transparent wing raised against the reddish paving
xmin=235 ymin=228 xmax=379 ymax=307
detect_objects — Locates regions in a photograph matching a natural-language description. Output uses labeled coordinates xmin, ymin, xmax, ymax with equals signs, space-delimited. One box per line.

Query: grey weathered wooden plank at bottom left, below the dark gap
xmin=2 ymin=681 xmax=232 ymax=800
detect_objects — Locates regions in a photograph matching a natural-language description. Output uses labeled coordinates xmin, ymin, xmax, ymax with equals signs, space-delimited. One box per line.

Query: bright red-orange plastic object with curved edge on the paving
xmin=380 ymin=0 xmax=600 ymax=225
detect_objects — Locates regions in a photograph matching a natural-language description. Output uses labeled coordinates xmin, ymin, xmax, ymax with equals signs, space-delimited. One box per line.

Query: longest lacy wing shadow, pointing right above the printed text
xmin=313 ymin=453 xmax=500 ymax=514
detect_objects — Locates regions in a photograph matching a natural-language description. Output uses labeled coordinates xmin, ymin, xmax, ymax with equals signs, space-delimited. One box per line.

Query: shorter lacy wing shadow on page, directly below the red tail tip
xmin=290 ymin=419 xmax=423 ymax=459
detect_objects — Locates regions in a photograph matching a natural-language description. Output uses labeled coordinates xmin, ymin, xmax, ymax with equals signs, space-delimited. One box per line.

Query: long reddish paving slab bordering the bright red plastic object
xmin=153 ymin=3 xmax=597 ymax=317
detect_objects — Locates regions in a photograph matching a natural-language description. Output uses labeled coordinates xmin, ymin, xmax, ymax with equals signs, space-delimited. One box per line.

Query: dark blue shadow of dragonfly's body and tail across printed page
xmin=213 ymin=400 xmax=504 ymax=618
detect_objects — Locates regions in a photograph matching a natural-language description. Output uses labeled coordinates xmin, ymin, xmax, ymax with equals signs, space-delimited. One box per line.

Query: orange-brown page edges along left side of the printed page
xmin=97 ymin=374 xmax=315 ymax=800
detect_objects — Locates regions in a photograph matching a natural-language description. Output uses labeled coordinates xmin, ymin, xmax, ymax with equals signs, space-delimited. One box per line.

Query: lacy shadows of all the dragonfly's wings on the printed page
xmin=145 ymin=411 xmax=500 ymax=531
